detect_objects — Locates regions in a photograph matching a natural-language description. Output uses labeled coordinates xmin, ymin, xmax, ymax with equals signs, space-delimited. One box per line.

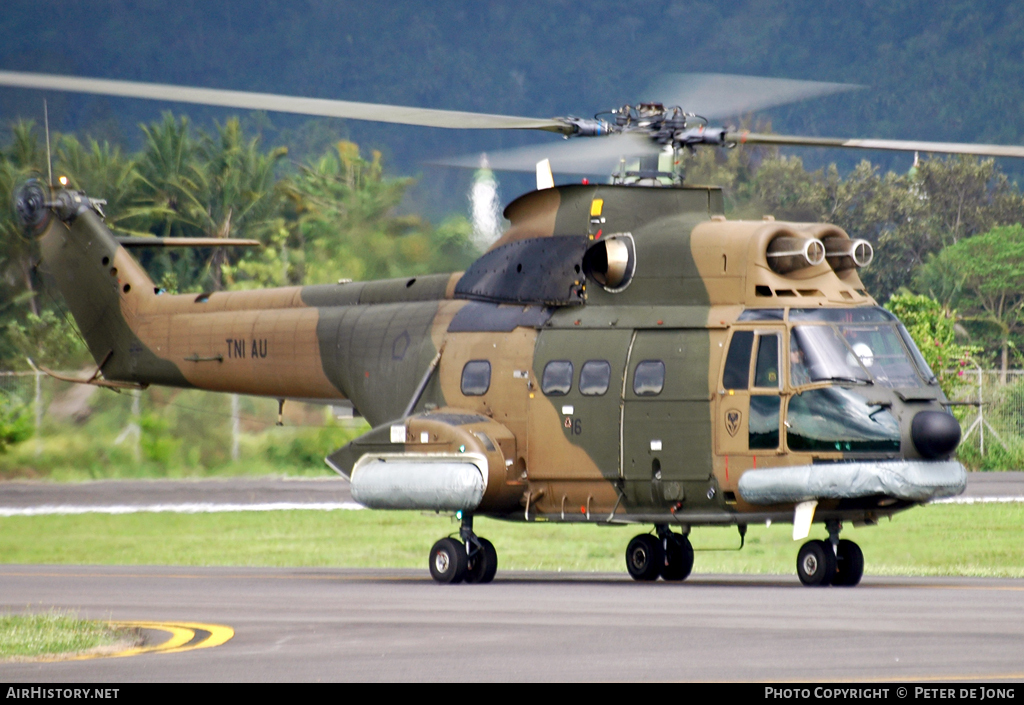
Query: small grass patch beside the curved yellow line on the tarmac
xmin=0 ymin=610 xmax=136 ymax=659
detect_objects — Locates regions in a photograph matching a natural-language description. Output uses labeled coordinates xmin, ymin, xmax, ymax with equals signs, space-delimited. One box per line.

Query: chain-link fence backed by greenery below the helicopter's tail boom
xmin=0 ymin=371 xmax=366 ymax=476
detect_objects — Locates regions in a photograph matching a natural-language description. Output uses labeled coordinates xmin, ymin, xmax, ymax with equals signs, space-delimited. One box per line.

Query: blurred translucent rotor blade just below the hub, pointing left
xmin=432 ymin=133 xmax=663 ymax=176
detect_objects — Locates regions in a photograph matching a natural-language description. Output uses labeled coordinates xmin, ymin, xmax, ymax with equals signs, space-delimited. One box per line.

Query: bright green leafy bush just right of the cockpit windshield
xmin=886 ymin=292 xmax=979 ymax=397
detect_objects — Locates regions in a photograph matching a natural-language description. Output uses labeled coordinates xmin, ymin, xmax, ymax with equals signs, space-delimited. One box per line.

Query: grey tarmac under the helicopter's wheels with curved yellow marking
xmin=0 ymin=566 xmax=1024 ymax=682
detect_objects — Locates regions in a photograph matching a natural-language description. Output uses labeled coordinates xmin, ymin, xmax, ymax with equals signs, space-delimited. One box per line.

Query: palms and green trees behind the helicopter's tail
xmin=0 ymin=114 xmax=478 ymax=369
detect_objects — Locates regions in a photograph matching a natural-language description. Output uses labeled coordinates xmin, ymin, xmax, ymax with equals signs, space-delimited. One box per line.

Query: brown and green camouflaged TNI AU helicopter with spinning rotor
xmin=6 ymin=72 xmax=1024 ymax=585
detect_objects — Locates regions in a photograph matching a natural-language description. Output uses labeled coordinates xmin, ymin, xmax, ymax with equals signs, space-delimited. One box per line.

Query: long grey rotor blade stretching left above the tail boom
xmin=0 ymin=71 xmax=572 ymax=134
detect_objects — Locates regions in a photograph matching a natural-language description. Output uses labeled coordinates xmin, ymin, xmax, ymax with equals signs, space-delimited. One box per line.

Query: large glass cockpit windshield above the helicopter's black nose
xmin=790 ymin=321 xmax=934 ymax=387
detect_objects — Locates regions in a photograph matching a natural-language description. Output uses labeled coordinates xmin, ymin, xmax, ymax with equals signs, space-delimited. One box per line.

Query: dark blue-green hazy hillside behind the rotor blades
xmin=0 ymin=0 xmax=1024 ymax=216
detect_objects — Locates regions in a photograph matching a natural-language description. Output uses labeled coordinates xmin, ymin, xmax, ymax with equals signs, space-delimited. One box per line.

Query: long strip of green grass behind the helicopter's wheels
xmin=0 ymin=503 xmax=1024 ymax=577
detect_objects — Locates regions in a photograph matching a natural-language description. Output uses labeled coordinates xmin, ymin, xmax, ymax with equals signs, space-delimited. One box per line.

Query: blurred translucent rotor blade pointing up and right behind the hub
xmin=648 ymin=74 xmax=865 ymax=120
